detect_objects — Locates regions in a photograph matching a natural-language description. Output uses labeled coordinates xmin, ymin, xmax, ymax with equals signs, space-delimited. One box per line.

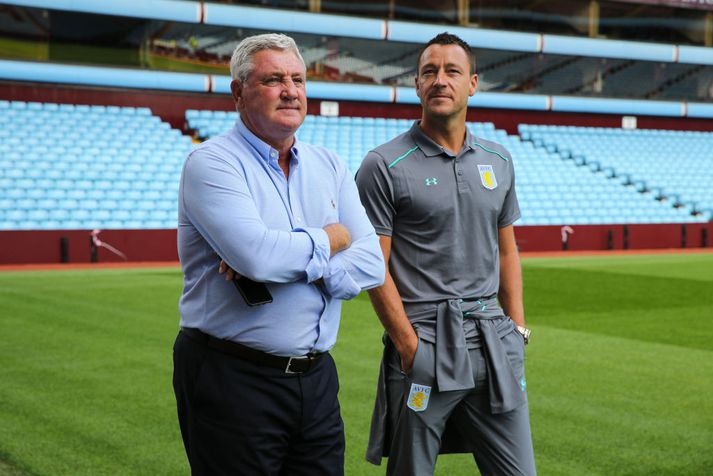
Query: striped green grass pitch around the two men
xmin=0 ymin=254 xmax=713 ymax=476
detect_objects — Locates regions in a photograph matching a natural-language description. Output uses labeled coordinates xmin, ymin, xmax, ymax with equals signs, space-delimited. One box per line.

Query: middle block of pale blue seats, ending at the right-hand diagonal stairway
xmin=186 ymin=110 xmax=713 ymax=225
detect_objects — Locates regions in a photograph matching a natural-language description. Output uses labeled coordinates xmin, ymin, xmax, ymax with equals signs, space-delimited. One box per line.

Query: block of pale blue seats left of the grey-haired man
xmin=0 ymin=101 xmax=192 ymax=230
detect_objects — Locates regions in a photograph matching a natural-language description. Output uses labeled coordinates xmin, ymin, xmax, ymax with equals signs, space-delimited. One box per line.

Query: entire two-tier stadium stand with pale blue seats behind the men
xmin=0 ymin=0 xmax=713 ymax=245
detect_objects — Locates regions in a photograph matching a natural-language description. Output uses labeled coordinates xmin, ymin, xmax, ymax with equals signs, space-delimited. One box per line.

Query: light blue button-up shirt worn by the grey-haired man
xmin=178 ymin=119 xmax=385 ymax=356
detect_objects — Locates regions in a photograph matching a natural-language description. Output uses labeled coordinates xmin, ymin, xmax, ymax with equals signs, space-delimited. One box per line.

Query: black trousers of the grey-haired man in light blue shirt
xmin=173 ymin=333 xmax=344 ymax=476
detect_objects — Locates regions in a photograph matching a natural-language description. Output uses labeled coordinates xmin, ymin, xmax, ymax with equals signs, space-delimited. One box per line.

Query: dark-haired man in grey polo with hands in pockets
xmin=357 ymin=33 xmax=535 ymax=475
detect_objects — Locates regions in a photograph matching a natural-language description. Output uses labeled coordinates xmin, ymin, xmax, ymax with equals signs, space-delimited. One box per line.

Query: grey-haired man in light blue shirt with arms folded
xmin=174 ymin=34 xmax=384 ymax=475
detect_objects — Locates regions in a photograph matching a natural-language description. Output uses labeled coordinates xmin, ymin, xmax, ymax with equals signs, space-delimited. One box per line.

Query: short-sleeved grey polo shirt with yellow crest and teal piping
xmin=356 ymin=121 xmax=520 ymax=314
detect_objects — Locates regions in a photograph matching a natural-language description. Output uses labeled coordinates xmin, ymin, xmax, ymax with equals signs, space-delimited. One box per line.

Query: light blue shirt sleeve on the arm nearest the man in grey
xmin=323 ymin=162 xmax=386 ymax=299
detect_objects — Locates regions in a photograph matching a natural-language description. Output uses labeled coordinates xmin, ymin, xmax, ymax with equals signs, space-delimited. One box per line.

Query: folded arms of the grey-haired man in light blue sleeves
xmin=181 ymin=150 xmax=384 ymax=299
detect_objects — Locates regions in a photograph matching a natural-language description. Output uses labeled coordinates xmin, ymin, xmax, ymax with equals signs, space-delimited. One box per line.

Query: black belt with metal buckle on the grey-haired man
xmin=181 ymin=327 xmax=326 ymax=374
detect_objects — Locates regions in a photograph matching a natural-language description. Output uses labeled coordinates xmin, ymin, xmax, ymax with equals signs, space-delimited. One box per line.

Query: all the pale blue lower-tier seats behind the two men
xmin=0 ymin=101 xmax=713 ymax=230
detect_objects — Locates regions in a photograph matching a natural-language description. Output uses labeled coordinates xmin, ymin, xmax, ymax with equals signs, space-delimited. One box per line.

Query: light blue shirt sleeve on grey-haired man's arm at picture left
xmin=181 ymin=149 xmax=330 ymax=283
